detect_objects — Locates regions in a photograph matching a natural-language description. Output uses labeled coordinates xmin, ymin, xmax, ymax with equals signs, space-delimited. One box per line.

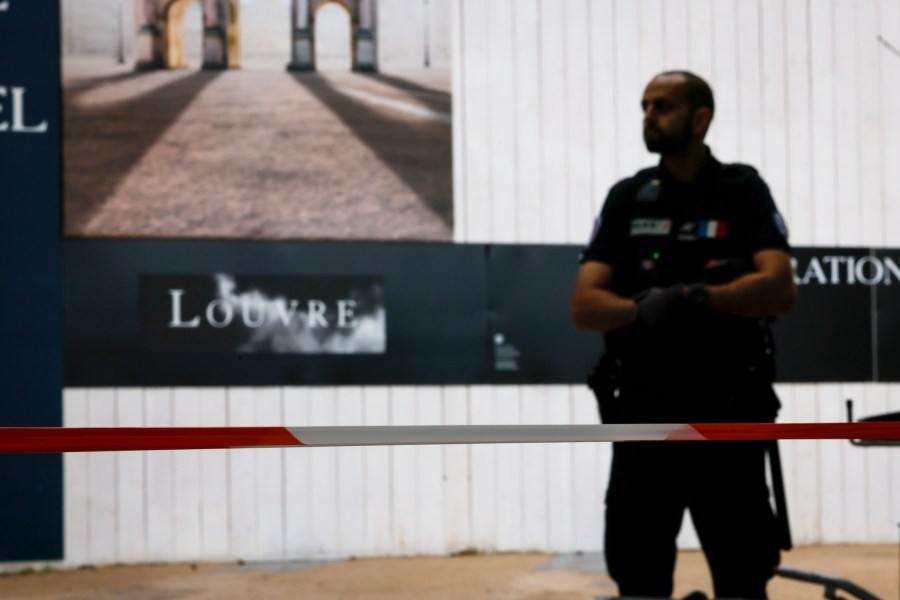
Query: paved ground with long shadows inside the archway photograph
xmin=63 ymin=57 xmax=453 ymax=240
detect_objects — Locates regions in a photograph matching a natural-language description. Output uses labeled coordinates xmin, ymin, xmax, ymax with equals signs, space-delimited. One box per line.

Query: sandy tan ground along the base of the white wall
xmin=0 ymin=544 xmax=900 ymax=600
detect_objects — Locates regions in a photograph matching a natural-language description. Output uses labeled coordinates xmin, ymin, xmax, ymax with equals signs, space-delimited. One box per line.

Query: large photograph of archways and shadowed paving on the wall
xmin=62 ymin=0 xmax=453 ymax=241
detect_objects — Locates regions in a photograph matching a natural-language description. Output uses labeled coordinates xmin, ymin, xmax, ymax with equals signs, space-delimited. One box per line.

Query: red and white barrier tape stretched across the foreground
xmin=0 ymin=421 xmax=900 ymax=454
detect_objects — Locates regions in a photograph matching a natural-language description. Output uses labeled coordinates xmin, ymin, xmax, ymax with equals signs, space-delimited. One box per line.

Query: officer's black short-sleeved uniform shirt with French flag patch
xmin=581 ymin=148 xmax=790 ymax=380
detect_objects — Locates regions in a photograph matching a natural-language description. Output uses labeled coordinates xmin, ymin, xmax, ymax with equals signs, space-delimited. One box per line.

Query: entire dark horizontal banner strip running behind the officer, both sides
xmin=65 ymin=240 xmax=900 ymax=386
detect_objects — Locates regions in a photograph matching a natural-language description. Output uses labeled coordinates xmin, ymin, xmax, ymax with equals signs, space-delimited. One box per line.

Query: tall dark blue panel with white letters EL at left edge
xmin=0 ymin=0 xmax=63 ymax=561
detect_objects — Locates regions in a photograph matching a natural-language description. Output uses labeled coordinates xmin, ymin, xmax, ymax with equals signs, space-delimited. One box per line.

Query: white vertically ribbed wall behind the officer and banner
xmin=64 ymin=0 xmax=900 ymax=565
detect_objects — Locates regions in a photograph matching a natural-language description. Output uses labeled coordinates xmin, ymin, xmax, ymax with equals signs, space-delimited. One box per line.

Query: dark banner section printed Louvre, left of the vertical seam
xmin=65 ymin=240 xmax=491 ymax=386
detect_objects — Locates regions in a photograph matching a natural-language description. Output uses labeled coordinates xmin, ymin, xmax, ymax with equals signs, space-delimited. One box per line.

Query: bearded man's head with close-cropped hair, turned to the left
xmin=641 ymin=71 xmax=715 ymax=155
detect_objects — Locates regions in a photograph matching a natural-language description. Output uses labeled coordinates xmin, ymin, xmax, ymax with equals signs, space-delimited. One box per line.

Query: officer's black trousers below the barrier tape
xmin=605 ymin=442 xmax=780 ymax=599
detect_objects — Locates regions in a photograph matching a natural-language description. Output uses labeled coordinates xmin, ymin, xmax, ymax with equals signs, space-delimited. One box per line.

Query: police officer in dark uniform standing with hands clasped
xmin=571 ymin=71 xmax=795 ymax=599
